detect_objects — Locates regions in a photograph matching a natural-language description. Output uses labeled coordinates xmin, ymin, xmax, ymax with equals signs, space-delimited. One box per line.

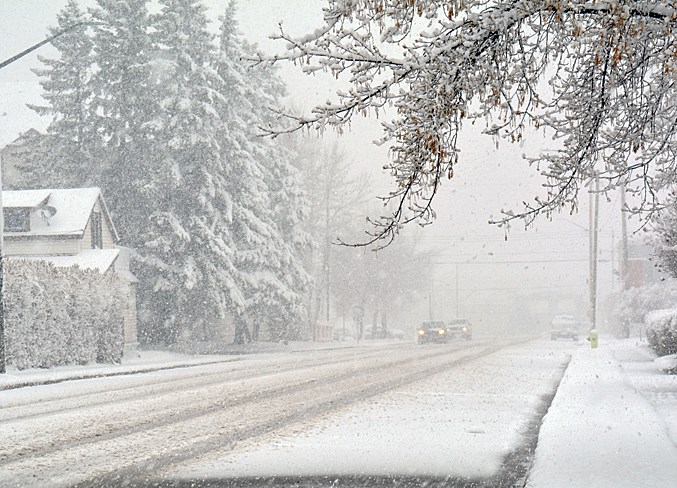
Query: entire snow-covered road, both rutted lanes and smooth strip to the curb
xmin=0 ymin=340 xmax=576 ymax=487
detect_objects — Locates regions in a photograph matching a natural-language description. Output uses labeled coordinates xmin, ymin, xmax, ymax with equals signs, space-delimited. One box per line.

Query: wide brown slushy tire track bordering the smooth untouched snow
xmin=0 ymin=345 xmax=528 ymax=486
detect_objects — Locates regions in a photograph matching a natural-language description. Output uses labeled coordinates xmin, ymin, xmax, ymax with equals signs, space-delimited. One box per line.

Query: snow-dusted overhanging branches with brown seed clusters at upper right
xmin=256 ymin=0 xmax=677 ymax=245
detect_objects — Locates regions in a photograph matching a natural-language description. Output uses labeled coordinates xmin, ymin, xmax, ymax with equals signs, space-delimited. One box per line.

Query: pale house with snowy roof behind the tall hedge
xmin=2 ymin=188 xmax=137 ymax=349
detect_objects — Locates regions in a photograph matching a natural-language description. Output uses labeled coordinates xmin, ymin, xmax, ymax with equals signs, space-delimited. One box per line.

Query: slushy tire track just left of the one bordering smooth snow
xmin=0 ymin=344 xmax=496 ymax=476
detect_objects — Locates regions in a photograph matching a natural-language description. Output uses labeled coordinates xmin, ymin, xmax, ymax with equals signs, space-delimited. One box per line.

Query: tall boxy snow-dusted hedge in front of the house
xmin=4 ymin=260 xmax=124 ymax=369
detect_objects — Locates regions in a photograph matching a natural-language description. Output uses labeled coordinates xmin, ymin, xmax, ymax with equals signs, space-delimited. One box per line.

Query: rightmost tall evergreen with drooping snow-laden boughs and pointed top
xmin=217 ymin=2 xmax=310 ymax=340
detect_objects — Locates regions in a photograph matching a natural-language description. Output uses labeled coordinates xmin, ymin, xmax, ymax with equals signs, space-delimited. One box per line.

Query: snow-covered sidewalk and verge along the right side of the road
xmin=527 ymin=338 xmax=677 ymax=488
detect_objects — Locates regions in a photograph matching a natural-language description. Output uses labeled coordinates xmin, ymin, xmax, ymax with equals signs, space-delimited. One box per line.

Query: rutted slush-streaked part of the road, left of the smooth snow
xmin=0 ymin=341 xmax=558 ymax=486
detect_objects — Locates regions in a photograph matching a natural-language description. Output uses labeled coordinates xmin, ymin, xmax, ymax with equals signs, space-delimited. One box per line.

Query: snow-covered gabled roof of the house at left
xmin=2 ymin=188 xmax=119 ymax=241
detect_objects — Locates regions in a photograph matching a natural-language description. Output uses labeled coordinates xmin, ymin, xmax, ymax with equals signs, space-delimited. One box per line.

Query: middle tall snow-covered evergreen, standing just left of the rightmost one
xmin=132 ymin=0 xmax=246 ymax=340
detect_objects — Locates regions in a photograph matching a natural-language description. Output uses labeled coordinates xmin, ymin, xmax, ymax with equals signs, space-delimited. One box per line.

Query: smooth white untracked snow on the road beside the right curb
xmin=164 ymin=341 xmax=572 ymax=478
